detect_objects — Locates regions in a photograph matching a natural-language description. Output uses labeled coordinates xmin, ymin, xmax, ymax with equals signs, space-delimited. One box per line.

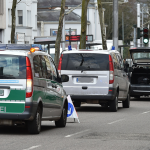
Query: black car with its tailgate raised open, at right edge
xmin=129 ymin=47 xmax=150 ymax=98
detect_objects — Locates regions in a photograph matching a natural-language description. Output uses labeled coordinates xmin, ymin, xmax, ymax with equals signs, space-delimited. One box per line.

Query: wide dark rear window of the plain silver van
xmin=61 ymin=53 xmax=109 ymax=71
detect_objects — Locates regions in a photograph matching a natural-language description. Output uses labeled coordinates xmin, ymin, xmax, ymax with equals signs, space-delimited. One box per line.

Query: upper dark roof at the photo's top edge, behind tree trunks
xmin=38 ymin=0 xmax=94 ymax=9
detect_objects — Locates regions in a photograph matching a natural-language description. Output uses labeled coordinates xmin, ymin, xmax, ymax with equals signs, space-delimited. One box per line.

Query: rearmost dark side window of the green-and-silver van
xmin=33 ymin=55 xmax=42 ymax=78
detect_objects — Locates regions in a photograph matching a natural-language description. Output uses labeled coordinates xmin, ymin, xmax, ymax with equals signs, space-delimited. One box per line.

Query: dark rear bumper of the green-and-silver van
xmin=0 ymin=102 xmax=38 ymax=120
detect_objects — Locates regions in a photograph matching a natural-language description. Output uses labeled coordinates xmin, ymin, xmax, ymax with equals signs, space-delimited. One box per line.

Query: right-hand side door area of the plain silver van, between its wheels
xmin=116 ymin=53 xmax=128 ymax=98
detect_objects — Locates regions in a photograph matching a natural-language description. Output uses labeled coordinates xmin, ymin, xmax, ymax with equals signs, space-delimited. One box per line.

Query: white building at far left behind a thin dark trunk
xmin=0 ymin=0 xmax=37 ymax=44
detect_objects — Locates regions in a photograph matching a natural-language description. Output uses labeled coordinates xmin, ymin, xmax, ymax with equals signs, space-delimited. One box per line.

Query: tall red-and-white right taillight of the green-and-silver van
xmin=26 ymin=57 xmax=33 ymax=98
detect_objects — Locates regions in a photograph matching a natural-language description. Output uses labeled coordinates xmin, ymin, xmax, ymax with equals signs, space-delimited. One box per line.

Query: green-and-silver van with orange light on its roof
xmin=0 ymin=44 xmax=68 ymax=134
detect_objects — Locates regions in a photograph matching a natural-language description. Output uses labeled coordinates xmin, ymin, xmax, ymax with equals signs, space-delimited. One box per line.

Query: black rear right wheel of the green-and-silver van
xmin=27 ymin=107 xmax=42 ymax=134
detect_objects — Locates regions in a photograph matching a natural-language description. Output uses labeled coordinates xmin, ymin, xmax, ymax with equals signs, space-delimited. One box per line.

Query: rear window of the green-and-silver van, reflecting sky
xmin=0 ymin=55 xmax=26 ymax=79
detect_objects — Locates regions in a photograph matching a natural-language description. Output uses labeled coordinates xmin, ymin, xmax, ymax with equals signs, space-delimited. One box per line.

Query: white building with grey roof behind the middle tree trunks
xmin=38 ymin=0 xmax=106 ymax=48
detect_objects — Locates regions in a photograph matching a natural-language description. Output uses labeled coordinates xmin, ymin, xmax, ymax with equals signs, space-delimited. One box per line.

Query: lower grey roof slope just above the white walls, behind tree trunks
xmin=37 ymin=10 xmax=89 ymax=23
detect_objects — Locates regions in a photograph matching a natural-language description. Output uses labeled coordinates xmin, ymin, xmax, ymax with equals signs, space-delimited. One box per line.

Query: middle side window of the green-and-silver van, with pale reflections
xmin=44 ymin=55 xmax=53 ymax=80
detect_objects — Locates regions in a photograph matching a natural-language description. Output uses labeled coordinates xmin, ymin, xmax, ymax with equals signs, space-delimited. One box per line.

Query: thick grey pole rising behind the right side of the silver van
xmin=113 ymin=0 xmax=118 ymax=50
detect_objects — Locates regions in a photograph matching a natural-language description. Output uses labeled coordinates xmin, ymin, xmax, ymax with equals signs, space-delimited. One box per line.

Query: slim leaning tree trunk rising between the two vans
xmin=54 ymin=0 xmax=66 ymax=67
